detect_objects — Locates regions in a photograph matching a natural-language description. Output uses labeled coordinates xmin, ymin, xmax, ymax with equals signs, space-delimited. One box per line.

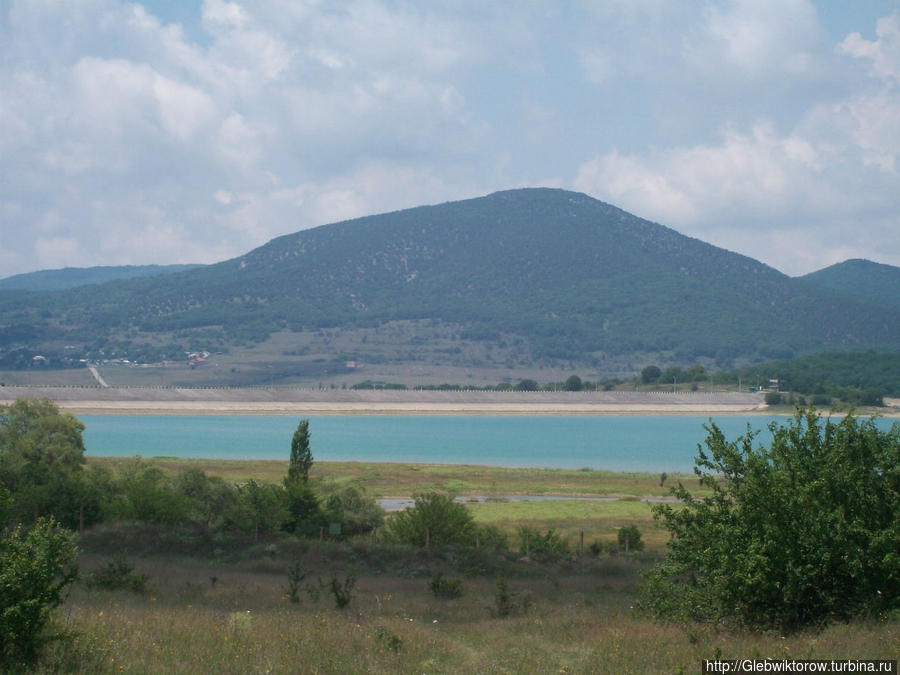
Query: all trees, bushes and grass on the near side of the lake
xmin=0 ymin=401 xmax=900 ymax=673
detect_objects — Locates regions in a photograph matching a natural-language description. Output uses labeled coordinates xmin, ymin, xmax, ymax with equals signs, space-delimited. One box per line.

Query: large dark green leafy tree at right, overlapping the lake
xmin=642 ymin=410 xmax=900 ymax=630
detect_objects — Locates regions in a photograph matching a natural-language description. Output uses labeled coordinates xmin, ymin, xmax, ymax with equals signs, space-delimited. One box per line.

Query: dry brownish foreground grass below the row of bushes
xmin=44 ymin=542 xmax=900 ymax=674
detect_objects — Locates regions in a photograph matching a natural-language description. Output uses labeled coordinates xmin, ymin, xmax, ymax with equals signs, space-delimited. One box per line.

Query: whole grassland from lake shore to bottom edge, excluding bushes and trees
xmin=42 ymin=459 xmax=900 ymax=674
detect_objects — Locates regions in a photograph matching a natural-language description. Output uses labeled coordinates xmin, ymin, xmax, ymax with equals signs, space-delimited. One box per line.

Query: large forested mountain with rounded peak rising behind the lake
xmin=0 ymin=188 xmax=900 ymax=366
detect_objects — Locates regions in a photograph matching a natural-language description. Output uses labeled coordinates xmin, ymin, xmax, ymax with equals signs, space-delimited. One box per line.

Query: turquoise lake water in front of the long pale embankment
xmin=79 ymin=415 xmax=891 ymax=472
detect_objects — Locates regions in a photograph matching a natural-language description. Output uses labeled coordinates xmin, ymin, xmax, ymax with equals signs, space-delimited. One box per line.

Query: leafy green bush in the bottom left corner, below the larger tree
xmin=0 ymin=518 xmax=77 ymax=672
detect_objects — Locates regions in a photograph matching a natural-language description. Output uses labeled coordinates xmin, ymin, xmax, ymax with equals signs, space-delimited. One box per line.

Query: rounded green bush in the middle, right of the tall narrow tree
xmin=386 ymin=492 xmax=476 ymax=546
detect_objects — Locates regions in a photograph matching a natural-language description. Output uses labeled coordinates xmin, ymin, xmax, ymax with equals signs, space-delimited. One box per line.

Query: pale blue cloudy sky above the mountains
xmin=0 ymin=0 xmax=900 ymax=277
